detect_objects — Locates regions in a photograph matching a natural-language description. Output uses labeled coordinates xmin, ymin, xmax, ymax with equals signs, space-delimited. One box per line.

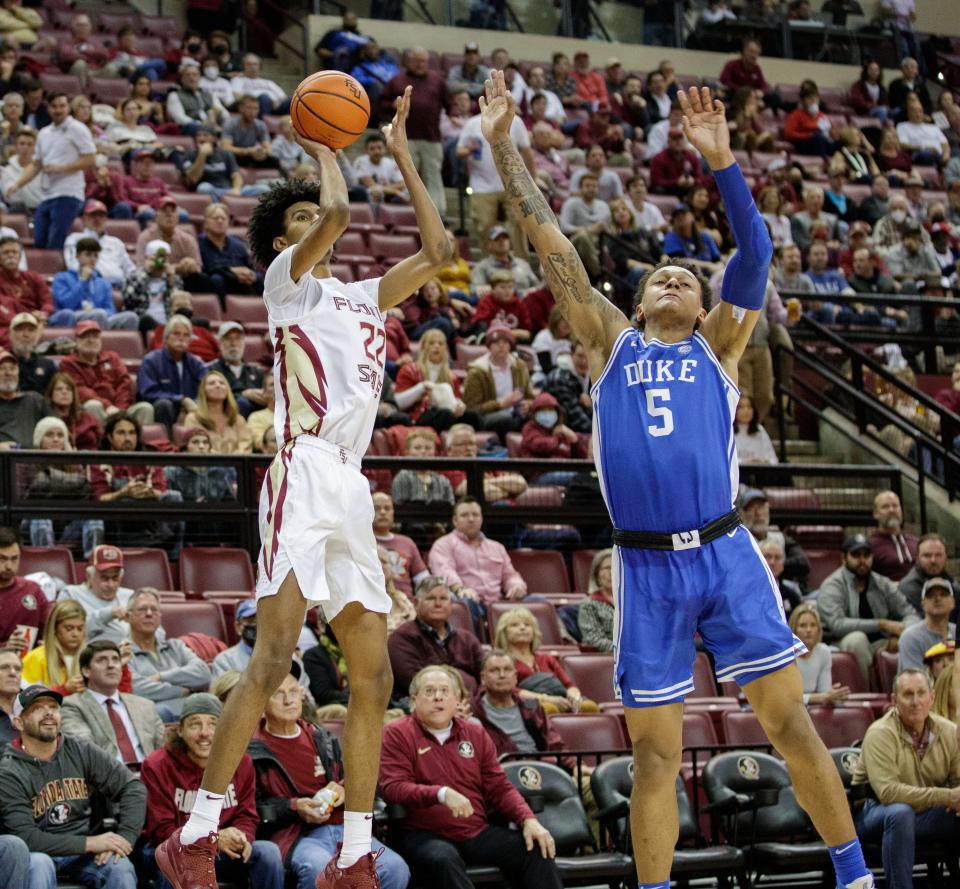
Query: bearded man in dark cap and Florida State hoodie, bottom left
xmin=0 ymin=685 xmax=146 ymax=889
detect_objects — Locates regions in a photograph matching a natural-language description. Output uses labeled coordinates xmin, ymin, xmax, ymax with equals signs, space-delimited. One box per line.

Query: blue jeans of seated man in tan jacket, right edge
xmin=855 ymin=799 xmax=960 ymax=889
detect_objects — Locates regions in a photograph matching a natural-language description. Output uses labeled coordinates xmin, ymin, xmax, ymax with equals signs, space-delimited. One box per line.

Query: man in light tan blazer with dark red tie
xmin=61 ymin=639 xmax=166 ymax=769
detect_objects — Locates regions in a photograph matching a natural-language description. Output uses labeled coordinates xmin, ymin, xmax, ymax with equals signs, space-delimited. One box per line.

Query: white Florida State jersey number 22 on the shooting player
xmin=263 ymin=247 xmax=386 ymax=456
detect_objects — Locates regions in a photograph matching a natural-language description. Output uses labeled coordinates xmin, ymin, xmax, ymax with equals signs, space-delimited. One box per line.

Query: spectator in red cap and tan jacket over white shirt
xmin=463 ymin=326 xmax=534 ymax=434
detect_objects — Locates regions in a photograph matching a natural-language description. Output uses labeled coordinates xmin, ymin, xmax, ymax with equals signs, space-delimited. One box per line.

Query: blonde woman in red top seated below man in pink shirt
xmin=494 ymin=607 xmax=599 ymax=713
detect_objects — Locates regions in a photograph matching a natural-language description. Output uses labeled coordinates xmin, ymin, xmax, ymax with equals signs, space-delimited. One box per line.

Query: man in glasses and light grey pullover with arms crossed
xmin=127 ymin=587 xmax=210 ymax=722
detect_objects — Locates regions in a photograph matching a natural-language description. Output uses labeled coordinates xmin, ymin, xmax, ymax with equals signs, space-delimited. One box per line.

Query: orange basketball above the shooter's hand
xmin=290 ymin=71 xmax=370 ymax=151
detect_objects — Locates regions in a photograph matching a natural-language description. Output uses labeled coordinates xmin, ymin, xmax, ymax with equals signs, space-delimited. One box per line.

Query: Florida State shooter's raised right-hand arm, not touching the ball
xmin=378 ymin=86 xmax=453 ymax=311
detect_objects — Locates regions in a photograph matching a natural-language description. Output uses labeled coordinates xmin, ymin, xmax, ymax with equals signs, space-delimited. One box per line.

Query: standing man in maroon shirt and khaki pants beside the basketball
xmin=383 ymin=46 xmax=450 ymax=216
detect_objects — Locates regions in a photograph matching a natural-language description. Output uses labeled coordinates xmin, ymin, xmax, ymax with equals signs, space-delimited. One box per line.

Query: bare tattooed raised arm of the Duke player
xmin=480 ymin=71 xmax=630 ymax=379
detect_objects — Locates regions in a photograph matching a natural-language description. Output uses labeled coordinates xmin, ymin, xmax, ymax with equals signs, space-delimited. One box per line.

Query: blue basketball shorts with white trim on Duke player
xmin=612 ymin=526 xmax=806 ymax=707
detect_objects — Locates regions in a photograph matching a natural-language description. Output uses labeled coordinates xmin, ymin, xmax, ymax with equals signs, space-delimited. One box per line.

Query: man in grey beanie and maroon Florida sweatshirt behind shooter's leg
xmin=140 ymin=693 xmax=284 ymax=889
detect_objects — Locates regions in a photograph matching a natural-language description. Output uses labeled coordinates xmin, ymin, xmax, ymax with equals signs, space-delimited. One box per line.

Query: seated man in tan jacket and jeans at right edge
xmin=853 ymin=670 xmax=960 ymax=886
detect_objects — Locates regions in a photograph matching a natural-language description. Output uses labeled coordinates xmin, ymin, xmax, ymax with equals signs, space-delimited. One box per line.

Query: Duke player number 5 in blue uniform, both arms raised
xmin=480 ymin=71 xmax=873 ymax=889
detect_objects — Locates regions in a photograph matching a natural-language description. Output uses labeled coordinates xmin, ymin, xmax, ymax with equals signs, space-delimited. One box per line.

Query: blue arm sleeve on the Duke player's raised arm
xmin=713 ymin=164 xmax=773 ymax=310
